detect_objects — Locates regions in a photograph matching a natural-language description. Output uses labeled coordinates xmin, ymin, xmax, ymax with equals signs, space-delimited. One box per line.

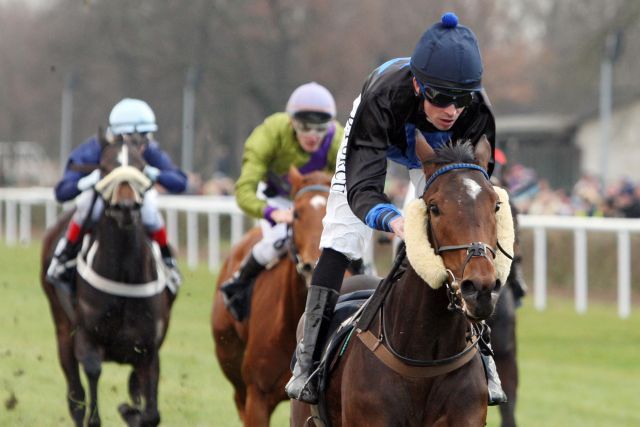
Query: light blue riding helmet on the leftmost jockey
xmin=109 ymin=98 xmax=158 ymax=135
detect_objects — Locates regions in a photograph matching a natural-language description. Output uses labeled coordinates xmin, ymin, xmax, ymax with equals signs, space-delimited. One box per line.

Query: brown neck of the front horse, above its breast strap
xmin=383 ymin=266 xmax=468 ymax=359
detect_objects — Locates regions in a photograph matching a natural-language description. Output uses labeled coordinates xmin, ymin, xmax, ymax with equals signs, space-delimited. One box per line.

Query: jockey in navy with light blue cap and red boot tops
xmin=47 ymin=98 xmax=187 ymax=301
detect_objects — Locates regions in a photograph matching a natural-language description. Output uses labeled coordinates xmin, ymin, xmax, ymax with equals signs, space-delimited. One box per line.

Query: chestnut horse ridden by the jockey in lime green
xmin=211 ymin=167 xmax=331 ymax=426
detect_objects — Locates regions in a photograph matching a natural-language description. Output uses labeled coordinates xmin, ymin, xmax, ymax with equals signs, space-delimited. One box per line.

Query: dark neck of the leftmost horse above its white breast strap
xmin=92 ymin=221 xmax=155 ymax=283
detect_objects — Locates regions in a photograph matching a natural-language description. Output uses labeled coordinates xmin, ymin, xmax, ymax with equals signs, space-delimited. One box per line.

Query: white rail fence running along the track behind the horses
xmin=0 ymin=188 xmax=640 ymax=318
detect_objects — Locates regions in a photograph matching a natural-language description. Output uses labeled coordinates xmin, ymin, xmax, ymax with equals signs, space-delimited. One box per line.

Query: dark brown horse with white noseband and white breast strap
xmin=41 ymin=137 xmax=171 ymax=426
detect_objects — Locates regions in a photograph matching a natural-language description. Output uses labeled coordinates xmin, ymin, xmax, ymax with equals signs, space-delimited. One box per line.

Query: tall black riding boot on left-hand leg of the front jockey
xmin=285 ymin=286 xmax=340 ymax=403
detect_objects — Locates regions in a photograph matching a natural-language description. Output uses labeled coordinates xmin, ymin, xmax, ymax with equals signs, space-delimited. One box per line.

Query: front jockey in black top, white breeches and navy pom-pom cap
xmin=286 ymin=13 xmax=505 ymax=404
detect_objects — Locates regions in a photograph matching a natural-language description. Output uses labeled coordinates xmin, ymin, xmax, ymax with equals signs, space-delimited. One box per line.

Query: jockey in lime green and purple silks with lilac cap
xmin=220 ymin=82 xmax=344 ymax=320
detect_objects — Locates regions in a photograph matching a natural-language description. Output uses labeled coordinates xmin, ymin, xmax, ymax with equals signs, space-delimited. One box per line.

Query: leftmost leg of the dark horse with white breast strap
xmin=56 ymin=320 xmax=86 ymax=427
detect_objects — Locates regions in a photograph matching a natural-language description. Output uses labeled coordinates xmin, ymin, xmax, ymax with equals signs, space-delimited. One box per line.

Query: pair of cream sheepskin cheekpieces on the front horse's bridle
xmin=404 ymin=186 xmax=515 ymax=289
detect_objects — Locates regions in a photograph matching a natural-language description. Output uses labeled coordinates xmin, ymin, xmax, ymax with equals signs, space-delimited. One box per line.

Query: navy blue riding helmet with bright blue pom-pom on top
xmin=410 ymin=12 xmax=483 ymax=95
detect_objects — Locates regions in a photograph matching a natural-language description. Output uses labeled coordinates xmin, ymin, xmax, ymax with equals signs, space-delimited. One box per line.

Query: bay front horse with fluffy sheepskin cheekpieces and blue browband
xmin=291 ymin=134 xmax=513 ymax=427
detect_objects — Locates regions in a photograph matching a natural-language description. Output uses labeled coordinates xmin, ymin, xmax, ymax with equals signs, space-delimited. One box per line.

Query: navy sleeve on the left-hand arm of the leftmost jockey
xmin=54 ymin=136 xmax=101 ymax=203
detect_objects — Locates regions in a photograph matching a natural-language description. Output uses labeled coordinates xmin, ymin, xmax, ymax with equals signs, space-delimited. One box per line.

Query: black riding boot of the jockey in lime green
xmin=220 ymin=254 xmax=265 ymax=322
